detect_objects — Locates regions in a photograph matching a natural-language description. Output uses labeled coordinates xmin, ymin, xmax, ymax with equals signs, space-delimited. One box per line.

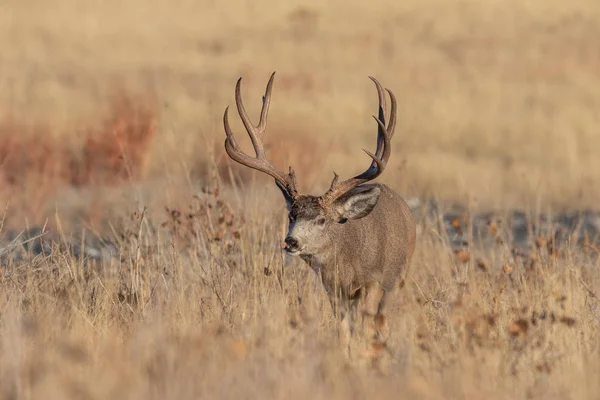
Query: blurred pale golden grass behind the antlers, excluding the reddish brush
xmin=0 ymin=0 xmax=600 ymax=206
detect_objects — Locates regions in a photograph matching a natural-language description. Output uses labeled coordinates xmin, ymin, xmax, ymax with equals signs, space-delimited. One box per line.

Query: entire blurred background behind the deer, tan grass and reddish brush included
xmin=0 ymin=0 xmax=600 ymax=231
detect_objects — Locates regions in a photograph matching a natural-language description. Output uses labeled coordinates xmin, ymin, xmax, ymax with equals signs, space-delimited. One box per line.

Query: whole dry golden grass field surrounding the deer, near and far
xmin=0 ymin=0 xmax=600 ymax=399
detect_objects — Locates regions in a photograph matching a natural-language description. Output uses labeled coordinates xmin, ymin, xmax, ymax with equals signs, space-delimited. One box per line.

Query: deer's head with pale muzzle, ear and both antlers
xmin=223 ymin=72 xmax=396 ymax=257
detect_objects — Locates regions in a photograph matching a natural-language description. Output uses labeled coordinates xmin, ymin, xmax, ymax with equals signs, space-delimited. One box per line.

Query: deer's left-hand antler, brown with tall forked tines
xmin=223 ymin=72 xmax=297 ymax=199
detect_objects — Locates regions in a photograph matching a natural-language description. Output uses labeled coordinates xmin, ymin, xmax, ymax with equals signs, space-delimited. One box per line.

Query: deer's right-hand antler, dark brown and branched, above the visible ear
xmin=322 ymin=76 xmax=397 ymax=202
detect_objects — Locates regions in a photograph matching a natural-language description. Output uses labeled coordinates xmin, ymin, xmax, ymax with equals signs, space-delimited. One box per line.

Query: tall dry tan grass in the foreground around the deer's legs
xmin=0 ymin=177 xmax=600 ymax=399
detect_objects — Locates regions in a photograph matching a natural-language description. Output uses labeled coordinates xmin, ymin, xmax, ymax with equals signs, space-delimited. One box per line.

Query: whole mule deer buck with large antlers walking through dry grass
xmin=223 ymin=72 xmax=416 ymax=356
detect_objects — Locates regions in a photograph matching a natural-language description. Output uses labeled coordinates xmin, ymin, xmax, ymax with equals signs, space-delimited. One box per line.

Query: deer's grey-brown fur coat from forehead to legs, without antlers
xmin=288 ymin=184 xmax=416 ymax=358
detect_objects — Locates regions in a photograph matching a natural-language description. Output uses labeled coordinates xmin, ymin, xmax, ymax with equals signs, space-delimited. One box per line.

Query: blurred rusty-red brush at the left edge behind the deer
xmin=0 ymin=92 xmax=155 ymax=187
